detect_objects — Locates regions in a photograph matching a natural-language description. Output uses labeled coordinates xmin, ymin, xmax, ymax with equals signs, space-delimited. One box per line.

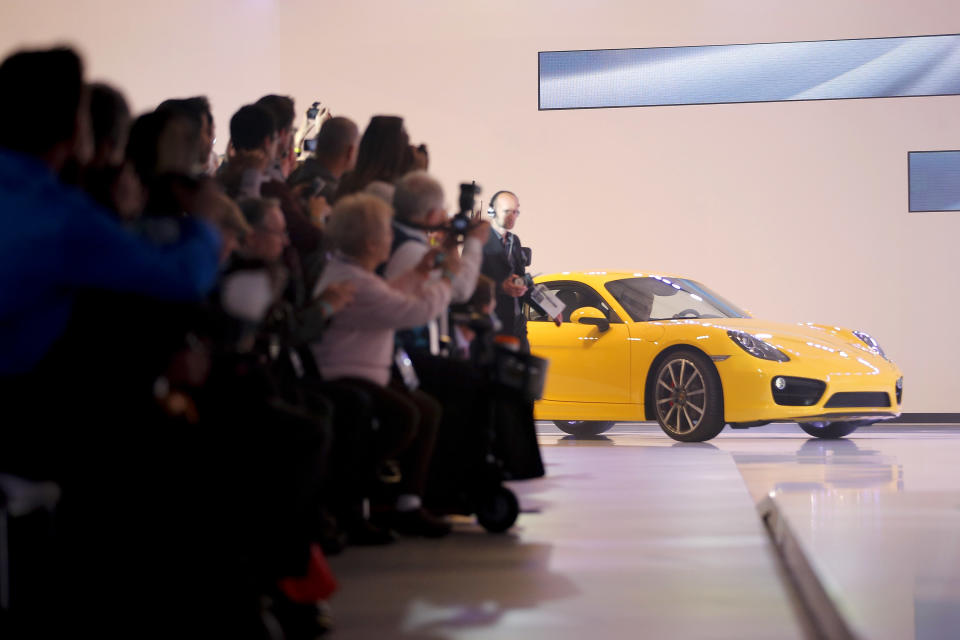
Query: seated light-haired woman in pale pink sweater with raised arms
xmin=312 ymin=193 xmax=459 ymax=537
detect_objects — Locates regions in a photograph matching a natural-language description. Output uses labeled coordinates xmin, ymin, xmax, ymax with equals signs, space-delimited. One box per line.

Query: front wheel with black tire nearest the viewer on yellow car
xmin=653 ymin=349 xmax=725 ymax=442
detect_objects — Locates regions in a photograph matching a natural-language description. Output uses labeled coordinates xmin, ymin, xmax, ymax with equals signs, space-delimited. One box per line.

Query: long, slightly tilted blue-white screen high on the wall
xmin=540 ymin=35 xmax=960 ymax=109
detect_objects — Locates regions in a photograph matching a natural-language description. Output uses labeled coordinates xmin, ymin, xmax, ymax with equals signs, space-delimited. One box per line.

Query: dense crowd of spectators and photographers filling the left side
xmin=0 ymin=49 xmax=539 ymax=638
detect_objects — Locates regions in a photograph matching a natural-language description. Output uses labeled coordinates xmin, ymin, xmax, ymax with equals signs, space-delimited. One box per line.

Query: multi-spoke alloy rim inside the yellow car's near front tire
xmin=654 ymin=358 xmax=707 ymax=435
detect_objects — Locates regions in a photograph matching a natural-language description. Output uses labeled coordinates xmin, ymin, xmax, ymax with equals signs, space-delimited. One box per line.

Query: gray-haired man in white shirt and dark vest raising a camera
xmin=384 ymin=171 xmax=490 ymax=355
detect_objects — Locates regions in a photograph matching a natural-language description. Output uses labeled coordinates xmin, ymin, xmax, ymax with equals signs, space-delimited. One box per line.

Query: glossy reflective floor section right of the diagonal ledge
xmin=723 ymin=429 xmax=960 ymax=640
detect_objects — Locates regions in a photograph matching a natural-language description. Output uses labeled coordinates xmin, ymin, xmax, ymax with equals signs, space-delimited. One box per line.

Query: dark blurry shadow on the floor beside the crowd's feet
xmin=331 ymin=536 xmax=578 ymax=640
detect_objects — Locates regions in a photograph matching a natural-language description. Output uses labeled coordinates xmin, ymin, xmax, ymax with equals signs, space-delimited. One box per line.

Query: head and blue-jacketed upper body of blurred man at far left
xmin=0 ymin=49 xmax=220 ymax=380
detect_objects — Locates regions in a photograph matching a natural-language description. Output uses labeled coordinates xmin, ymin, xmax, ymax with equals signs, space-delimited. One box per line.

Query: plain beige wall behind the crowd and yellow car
xmin=0 ymin=0 xmax=960 ymax=412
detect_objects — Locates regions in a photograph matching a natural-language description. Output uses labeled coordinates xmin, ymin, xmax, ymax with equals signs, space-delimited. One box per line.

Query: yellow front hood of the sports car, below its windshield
xmin=661 ymin=318 xmax=890 ymax=368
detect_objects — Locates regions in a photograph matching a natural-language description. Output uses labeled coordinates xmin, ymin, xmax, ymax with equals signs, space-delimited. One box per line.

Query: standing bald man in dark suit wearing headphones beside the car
xmin=480 ymin=191 xmax=559 ymax=353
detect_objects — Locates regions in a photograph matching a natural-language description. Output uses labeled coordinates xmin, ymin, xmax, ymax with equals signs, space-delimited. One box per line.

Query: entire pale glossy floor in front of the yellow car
xmin=331 ymin=425 xmax=960 ymax=639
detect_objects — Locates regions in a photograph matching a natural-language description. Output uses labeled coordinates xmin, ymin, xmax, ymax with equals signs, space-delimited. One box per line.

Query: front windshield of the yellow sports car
xmin=606 ymin=276 xmax=750 ymax=322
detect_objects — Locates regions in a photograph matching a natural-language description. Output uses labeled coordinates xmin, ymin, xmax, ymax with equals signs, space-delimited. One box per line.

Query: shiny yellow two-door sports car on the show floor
xmin=525 ymin=271 xmax=903 ymax=442
